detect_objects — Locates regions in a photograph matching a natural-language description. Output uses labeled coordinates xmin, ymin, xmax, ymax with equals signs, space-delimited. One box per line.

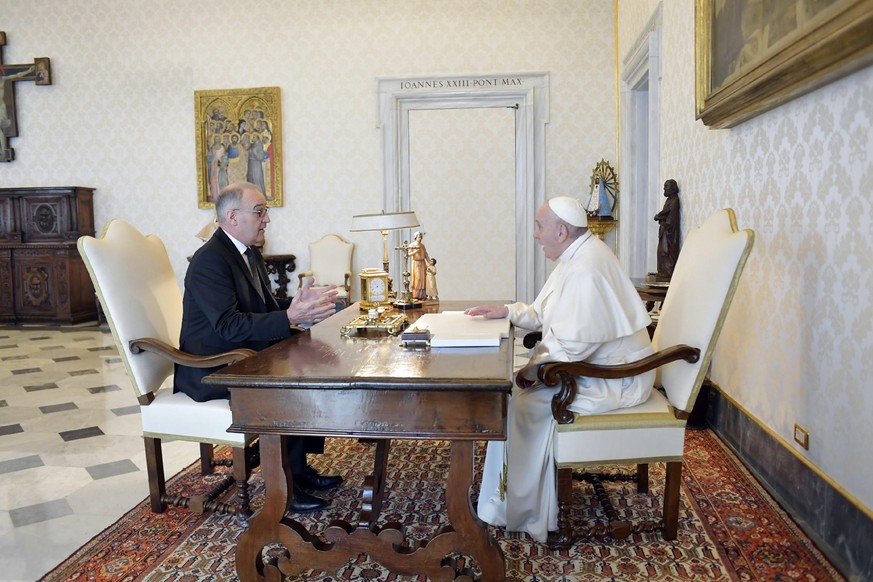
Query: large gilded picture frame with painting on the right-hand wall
xmin=694 ymin=0 xmax=873 ymax=128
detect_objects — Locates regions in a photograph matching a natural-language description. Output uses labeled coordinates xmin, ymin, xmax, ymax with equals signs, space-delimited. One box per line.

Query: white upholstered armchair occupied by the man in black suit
xmin=78 ymin=220 xmax=257 ymax=517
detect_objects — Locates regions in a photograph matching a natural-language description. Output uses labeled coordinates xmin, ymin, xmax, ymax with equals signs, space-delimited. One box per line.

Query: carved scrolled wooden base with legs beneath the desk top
xmin=236 ymin=434 xmax=505 ymax=581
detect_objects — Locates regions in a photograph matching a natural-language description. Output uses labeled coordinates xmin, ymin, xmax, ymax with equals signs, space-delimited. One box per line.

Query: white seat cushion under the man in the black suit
xmin=140 ymin=388 xmax=247 ymax=447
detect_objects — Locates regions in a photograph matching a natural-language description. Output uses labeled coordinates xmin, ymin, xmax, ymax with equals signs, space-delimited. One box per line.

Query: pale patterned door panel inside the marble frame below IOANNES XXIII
xmin=409 ymin=107 xmax=516 ymax=301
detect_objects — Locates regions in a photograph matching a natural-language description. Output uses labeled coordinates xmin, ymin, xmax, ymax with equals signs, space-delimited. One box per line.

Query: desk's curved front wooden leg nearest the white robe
xmin=446 ymin=441 xmax=506 ymax=581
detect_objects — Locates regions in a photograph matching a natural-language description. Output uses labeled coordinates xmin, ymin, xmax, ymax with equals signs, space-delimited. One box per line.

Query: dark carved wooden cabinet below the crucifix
xmin=0 ymin=186 xmax=97 ymax=324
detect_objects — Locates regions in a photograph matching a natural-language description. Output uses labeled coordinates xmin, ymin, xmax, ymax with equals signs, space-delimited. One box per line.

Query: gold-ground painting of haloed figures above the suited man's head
xmin=194 ymin=87 xmax=282 ymax=208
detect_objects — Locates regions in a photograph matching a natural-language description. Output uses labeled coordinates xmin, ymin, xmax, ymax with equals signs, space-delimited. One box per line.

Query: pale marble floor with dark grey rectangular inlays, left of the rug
xmin=0 ymin=326 xmax=199 ymax=582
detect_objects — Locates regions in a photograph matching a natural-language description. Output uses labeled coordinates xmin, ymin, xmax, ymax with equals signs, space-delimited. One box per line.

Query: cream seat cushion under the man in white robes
xmin=555 ymin=390 xmax=685 ymax=468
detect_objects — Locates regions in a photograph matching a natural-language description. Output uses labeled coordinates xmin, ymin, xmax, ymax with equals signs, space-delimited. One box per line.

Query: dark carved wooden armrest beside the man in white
xmin=537 ymin=344 xmax=700 ymax=424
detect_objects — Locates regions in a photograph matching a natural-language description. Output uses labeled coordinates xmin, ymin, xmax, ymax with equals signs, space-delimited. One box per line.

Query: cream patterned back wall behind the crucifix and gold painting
xmin=0 ymin=0 xmax=615 ymax=302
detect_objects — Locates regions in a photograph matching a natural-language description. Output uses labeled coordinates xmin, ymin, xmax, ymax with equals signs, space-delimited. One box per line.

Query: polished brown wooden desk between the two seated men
xmin=205 ymin=301 xmax=513 ymax=582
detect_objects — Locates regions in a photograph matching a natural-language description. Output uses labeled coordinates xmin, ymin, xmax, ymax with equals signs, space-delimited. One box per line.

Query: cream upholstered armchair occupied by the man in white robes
xmin=520 ymin=209 xmax=754 ymax=548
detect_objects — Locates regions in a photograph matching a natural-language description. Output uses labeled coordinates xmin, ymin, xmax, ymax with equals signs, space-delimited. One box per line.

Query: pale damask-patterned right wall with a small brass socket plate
xmin=618 ymin=0 xmax=873 ymax=511
